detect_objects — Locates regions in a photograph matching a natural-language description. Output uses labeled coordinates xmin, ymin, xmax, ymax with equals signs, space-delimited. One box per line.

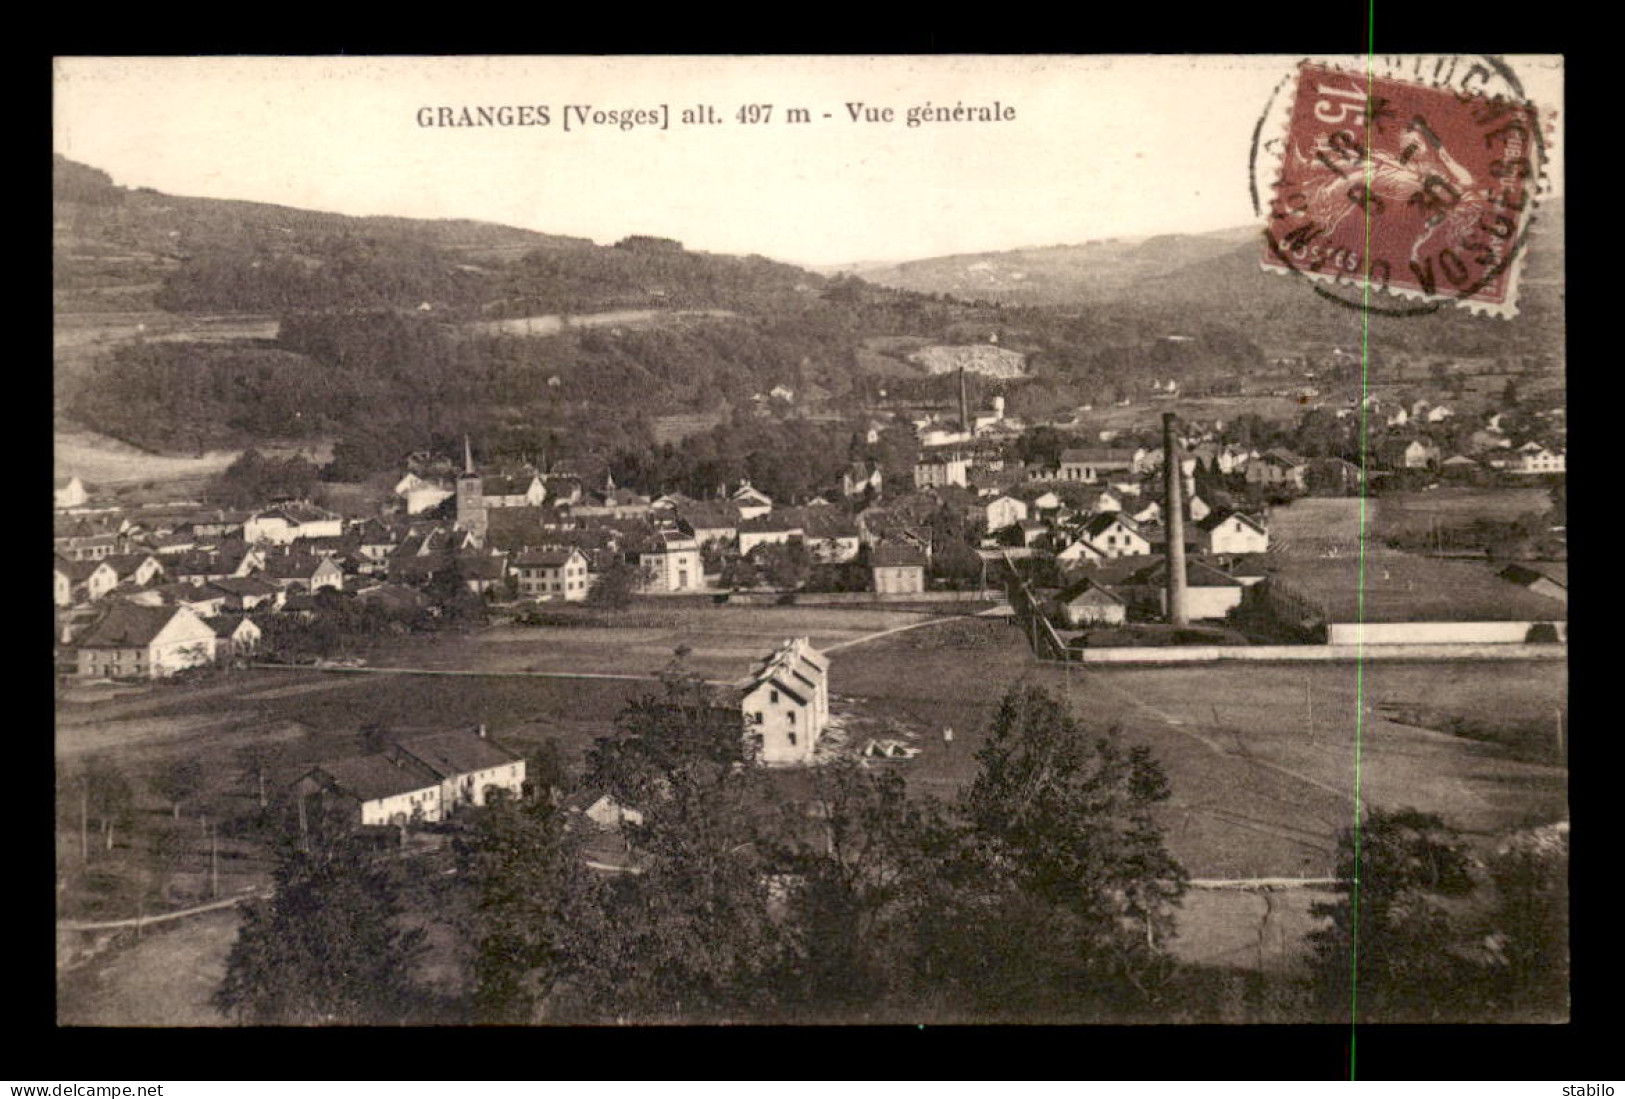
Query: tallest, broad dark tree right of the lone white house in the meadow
xmin=928 ymin=688 xmax=1186 ymax=1011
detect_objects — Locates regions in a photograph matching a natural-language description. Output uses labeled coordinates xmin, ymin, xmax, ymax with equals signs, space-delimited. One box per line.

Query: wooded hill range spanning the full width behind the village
xmin=54 ymin=156 xmax=1562 ymax=476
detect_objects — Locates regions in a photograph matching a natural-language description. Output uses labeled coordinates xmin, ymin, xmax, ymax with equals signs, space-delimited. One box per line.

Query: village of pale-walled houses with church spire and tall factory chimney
xmin=54 ymin=360 xmax=1567 ymax=683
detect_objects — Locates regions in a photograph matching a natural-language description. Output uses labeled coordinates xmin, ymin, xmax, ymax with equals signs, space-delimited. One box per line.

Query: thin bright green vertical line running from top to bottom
xmin=1349 ymin=15 xmax=1376 ymax=1079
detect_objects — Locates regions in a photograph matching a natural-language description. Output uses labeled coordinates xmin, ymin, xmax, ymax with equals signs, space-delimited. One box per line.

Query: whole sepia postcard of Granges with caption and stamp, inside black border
xmin=50 ymin=52 xmax=1580 ymax=1027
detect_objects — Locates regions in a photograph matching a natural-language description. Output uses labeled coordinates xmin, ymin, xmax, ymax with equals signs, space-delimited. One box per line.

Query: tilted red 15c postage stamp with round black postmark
xmin=1263 ymin=62 xmax=1542 ymax=317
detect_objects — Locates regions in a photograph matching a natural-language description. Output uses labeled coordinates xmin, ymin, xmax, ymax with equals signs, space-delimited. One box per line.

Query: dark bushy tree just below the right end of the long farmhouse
xmin=455 ymin=793 xmax=601 ymax=1024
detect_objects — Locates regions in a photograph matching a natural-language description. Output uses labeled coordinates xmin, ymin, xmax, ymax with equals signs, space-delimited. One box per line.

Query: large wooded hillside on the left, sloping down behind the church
xmin=54 ymin=156 xmax=998 ymax=473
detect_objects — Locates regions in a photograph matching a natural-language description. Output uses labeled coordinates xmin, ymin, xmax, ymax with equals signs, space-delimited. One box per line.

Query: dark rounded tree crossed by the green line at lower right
xmin=1308 ymin=808 xmax=1474 ymax=1023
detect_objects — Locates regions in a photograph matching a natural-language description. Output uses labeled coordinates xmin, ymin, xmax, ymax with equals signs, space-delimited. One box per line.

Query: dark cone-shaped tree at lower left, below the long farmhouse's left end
xmin=215 ymin=818 xmax=426 ymax=1026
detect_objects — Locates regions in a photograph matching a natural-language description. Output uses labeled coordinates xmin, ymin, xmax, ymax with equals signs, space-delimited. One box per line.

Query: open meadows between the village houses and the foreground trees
xmin=57 ymin=606 xmax=1567 ymax=1021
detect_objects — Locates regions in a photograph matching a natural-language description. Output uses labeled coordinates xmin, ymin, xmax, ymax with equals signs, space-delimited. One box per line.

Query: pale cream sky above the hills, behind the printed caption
xmin=54 ymin=55 xmax=1563 ymax=265
